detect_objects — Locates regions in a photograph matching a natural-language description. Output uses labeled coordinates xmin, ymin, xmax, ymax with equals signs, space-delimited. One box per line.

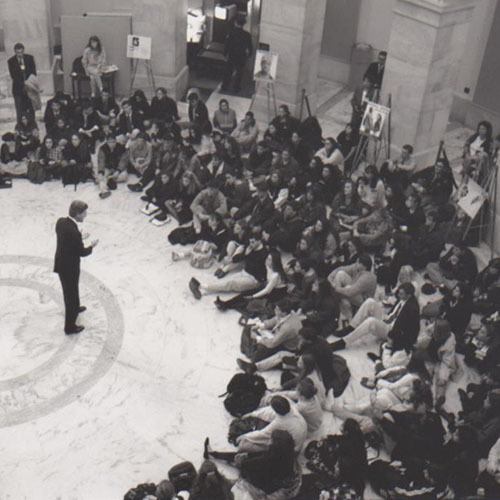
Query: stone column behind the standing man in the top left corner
xmin=0 ymin=0 xmax=54 ymax=96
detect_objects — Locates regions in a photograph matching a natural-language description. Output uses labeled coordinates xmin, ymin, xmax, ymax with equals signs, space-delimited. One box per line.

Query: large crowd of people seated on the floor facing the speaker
xmin=0 ymin=83 xmax=500 ymax=500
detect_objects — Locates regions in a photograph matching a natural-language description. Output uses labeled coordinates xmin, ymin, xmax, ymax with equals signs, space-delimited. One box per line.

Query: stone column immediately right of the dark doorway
xmin=257 ymin=0 xmax=326 ymax=118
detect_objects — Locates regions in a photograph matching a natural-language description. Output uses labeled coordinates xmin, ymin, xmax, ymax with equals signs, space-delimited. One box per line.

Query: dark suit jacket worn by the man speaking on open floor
xmin=54 ymin=217 xmax=92 ymax=274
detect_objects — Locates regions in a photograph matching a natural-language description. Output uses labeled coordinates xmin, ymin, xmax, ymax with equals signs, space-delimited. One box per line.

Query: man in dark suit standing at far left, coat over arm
xmin=7 ymin=43 xmax=36 ymax=123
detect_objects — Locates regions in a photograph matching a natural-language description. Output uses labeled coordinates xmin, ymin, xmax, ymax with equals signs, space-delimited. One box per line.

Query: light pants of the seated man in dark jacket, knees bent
xmin=344 ymin=299 xmax=391 ymax=346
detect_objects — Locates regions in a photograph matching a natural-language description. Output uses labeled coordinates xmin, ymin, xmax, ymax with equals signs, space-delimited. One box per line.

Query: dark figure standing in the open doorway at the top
xmin=221 ymin=16 xmax=253 ymax=92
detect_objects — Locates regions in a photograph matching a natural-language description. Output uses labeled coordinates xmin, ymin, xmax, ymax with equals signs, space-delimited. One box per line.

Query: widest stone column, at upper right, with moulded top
xmin=382 ymin=0 xmax=476 ymax=167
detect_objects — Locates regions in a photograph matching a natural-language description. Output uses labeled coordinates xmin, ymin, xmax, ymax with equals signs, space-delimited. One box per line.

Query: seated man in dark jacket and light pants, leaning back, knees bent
xmin=330 ymin=283 xmax=420 ymax=351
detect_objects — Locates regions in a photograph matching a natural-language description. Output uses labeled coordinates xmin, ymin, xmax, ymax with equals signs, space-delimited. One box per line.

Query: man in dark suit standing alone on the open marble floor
xmin=54 ymin=200 xmax=98 ymax=335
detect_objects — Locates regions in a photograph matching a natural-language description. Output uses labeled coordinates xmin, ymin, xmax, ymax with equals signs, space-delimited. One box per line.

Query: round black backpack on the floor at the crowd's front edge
xmin=221 ymin=373 xmax=267 ymax=417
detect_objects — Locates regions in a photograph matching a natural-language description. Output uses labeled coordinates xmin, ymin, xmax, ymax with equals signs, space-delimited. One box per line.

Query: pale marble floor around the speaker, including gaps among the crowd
xmin=0 ymin=84 xmax=478 ymax=500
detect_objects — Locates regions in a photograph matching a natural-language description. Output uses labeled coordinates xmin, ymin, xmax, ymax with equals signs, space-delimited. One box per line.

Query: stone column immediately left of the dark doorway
xmin=132 ymin=0 xmax=188 ymax=100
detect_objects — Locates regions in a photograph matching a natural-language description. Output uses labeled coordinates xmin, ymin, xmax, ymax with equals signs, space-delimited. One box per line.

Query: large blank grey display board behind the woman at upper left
xmin=61 ymin=13 xmax=132 ymax=95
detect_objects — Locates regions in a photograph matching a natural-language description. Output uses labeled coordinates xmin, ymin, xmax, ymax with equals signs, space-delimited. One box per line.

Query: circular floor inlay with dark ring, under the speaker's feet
xmin=0 ymin=255 xmax=124 ymax=427
